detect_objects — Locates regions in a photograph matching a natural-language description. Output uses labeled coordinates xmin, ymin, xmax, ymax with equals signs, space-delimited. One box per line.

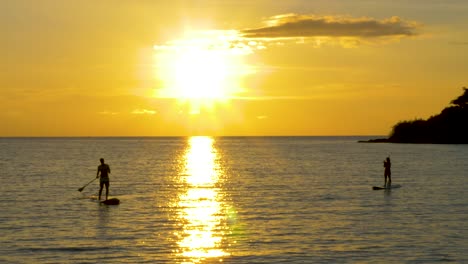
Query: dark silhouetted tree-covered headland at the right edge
xmin=369 ymin=87 xmax=468 ymax=144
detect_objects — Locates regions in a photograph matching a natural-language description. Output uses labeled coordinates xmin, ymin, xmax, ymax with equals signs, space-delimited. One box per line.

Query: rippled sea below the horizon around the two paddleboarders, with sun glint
xmin=0 ymin=137 xmax=468 ymax=263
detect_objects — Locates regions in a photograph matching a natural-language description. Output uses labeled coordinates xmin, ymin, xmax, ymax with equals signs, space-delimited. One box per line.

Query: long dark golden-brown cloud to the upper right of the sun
xmin=241 ymin=14 xmax=419 ymax=39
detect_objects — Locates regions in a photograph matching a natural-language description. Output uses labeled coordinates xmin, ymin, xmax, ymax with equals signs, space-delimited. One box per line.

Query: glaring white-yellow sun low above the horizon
xmin=154 ymin=31 xmax=252 ymax=114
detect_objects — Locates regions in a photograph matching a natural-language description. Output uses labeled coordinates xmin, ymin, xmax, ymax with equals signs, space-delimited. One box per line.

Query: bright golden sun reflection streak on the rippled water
xmin=176 ymin=137 xmax=229 ymax=263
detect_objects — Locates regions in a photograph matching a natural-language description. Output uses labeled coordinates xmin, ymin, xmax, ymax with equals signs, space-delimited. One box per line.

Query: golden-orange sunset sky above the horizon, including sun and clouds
xmin=0 ymin=0 xmax=468 ymax=136
